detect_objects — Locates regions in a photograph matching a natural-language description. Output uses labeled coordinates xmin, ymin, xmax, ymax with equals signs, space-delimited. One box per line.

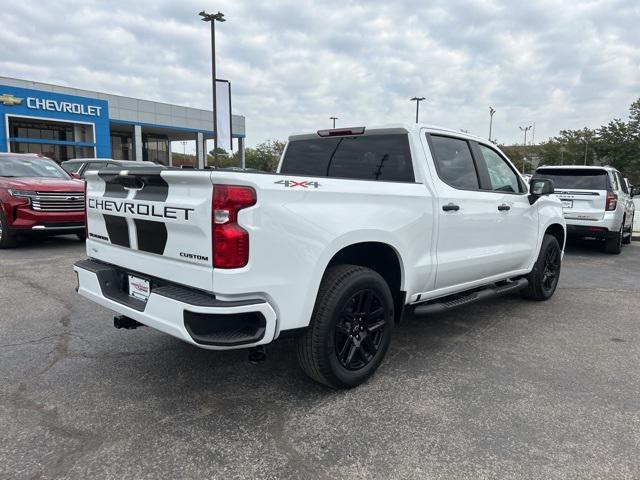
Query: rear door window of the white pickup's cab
xmin=431 ymin=135 xmax=480 ymax=190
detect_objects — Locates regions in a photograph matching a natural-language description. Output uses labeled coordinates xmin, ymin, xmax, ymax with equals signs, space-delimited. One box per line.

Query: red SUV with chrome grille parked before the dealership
xmin=0 ymin=153 xmax=85 ymax=248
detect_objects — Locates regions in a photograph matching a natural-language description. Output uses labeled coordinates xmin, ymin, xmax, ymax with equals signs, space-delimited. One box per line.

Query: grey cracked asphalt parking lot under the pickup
xmin=0 ymin=237 xmax=640 ymax=479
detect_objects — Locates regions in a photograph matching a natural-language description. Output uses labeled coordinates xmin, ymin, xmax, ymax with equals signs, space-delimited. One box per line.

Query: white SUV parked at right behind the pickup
xmin=533 ymin=165 xmax=635 ymax=254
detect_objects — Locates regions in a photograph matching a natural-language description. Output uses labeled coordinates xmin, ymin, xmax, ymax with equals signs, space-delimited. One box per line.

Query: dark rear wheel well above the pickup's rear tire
xmin=324 ymin=242 xmax=406 ymax=322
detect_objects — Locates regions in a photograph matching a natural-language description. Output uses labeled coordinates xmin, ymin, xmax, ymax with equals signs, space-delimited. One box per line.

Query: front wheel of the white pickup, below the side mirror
xmin=521 ymin=234 xmax=562 ymax=301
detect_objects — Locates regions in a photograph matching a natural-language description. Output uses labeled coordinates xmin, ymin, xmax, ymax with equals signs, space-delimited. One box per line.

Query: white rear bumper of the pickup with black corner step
xmin=74 ymin=260 xmax=276 ymax=350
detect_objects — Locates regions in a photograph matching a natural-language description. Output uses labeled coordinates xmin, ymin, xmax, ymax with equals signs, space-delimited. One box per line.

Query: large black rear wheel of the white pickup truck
xmin=296 ymin=265 xmax=394 ymax=389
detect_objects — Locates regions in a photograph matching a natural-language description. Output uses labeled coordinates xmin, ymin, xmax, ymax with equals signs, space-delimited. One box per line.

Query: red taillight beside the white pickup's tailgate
xmin=211 ymin=185 xmax=256 ymax=268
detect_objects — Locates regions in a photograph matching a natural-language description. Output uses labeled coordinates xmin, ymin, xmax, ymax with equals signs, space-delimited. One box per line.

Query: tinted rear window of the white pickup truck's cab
xmin=280 ymin=134 xmax=415 ymax=182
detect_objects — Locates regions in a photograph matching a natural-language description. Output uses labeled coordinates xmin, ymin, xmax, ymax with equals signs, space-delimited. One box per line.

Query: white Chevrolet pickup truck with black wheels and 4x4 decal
xmin=74 ymin=125 xmax=566 ymax=388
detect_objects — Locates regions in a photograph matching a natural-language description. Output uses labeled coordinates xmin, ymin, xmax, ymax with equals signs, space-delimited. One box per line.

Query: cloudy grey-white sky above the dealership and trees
xmin=0 ymin=0 xmax=640 ymax=145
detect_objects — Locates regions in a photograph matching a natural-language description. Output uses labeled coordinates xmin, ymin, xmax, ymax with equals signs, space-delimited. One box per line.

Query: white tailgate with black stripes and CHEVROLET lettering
xmin=86 ymin=168 xmax=213 ymax=291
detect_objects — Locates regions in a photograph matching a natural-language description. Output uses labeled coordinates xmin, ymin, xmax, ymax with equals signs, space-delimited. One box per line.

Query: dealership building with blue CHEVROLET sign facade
xmin=0 ymin=76 xmax=245 ymax=168
